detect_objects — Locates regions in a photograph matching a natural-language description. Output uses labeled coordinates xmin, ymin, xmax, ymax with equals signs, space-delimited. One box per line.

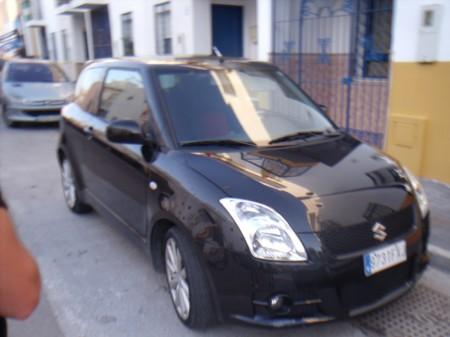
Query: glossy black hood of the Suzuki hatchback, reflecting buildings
xmin=188 ymin=135 xmax=412 ymax=232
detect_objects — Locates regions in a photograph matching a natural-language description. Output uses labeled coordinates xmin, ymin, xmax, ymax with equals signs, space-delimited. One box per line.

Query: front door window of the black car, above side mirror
xmin=99 ymin=69 xmax=148 ymax=124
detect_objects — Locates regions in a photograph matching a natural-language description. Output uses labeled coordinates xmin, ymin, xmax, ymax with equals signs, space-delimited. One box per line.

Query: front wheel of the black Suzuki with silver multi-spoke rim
xmin=164 ymin=227 xmax=215 ymax=329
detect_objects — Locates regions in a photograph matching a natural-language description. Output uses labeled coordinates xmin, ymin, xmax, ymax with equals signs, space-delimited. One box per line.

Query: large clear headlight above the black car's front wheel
xmin=220 ymin=198 xmax=308 ymax=261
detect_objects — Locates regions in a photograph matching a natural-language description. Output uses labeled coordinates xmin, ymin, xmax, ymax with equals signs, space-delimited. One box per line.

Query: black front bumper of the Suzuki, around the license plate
xmin=209 ymin=220 xmax=428 ymax=327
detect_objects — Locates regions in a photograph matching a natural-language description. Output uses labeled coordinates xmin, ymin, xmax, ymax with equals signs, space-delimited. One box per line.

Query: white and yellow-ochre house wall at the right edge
xmin=386 ymin=0 xmax=450 ymax=183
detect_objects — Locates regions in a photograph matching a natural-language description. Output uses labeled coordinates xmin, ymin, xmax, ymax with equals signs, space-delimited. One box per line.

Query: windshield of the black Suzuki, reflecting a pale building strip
xmin=155 ymin=65 xmax=334 ymax=145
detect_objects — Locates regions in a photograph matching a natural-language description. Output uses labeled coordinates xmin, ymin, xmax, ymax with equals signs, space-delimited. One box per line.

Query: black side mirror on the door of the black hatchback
xmin=106 ymin=120 xmax=146 ymax=144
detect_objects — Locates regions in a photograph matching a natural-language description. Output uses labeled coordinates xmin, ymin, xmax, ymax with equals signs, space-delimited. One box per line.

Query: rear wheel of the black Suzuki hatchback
xmin=61 ymin=157 xmax=92 ymax=214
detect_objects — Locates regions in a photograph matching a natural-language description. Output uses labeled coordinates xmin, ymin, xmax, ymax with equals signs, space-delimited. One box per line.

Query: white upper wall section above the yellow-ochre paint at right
xmin=392 ymin=0 xmax=450 ymax=62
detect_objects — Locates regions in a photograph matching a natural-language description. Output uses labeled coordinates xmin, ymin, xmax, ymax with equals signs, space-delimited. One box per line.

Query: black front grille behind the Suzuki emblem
xmin=317 ymin=206 xmax=414 ymax=256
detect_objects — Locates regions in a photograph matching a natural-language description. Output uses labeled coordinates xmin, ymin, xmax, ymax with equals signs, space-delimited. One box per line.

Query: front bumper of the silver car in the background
xmin=5 ymin=104 xmax=63 ymax=123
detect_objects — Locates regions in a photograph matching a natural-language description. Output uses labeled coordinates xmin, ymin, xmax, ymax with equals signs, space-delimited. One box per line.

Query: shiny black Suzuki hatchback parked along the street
xmin=58 ymin=58 xmax=429 ymax=328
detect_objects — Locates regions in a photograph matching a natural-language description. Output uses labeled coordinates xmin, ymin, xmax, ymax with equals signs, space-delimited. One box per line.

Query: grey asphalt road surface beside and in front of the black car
xmin=0 ymin=125 xmax=450 ymax=337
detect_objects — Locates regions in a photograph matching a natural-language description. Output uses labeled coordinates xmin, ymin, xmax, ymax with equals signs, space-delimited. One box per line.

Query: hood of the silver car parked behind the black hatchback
xmin=3 ymin=82 xmax=74 ymax=101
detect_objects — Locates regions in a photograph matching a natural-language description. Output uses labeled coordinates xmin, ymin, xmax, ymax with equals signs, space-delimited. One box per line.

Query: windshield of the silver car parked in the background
xmin=6 ymin=63 xmax=68 ymax=83
